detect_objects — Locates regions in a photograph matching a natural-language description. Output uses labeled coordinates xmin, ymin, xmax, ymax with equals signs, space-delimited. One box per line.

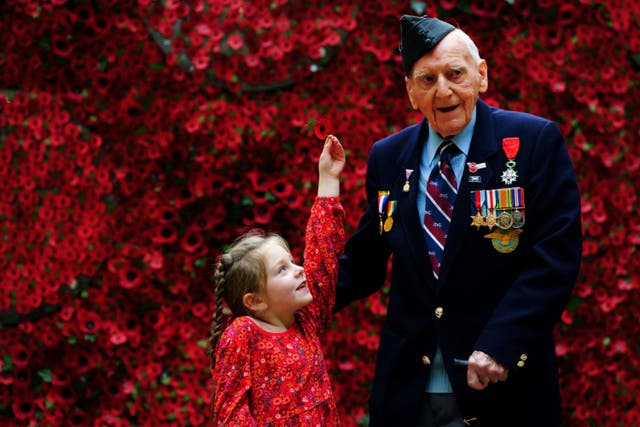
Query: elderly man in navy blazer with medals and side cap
xmin=336 ymin=15 xmax=582 ymax=427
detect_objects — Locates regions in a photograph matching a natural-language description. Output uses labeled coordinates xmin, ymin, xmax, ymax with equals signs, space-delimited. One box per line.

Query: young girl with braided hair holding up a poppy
xmin=209 ymin=135 xmax=345 ymax=427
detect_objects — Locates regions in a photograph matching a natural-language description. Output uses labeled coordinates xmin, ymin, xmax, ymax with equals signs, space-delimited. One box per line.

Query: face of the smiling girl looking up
xmin=260 ymin=242 xmax=313 ymax=319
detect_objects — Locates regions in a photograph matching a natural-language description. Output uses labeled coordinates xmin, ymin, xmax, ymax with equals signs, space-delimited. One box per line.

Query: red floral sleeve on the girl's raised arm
xmin=301 ymin=197 xmax=345 ymax=334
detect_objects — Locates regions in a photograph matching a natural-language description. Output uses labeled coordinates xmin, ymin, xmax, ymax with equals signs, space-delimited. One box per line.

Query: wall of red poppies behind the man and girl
xmin=0 ymin=0 xmax=640 ymax=426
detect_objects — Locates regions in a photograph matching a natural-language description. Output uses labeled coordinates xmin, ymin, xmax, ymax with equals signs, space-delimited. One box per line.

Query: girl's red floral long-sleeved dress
xmin=213 ymin=197 xmax=345 ymax=427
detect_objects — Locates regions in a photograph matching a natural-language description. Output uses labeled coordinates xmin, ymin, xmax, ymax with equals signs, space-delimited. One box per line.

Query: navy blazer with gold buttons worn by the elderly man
xmin=336 ymin=100 xmax=582 ymax=427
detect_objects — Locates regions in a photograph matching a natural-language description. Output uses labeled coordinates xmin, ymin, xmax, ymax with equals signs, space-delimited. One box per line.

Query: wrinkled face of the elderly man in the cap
xmin=405 ymin=31 xmax=488 ymax=138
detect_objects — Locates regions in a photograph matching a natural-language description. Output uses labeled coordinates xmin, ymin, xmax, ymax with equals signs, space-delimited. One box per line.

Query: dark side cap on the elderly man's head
xmin=400 ymin=15 xmax=455 ymax=76
